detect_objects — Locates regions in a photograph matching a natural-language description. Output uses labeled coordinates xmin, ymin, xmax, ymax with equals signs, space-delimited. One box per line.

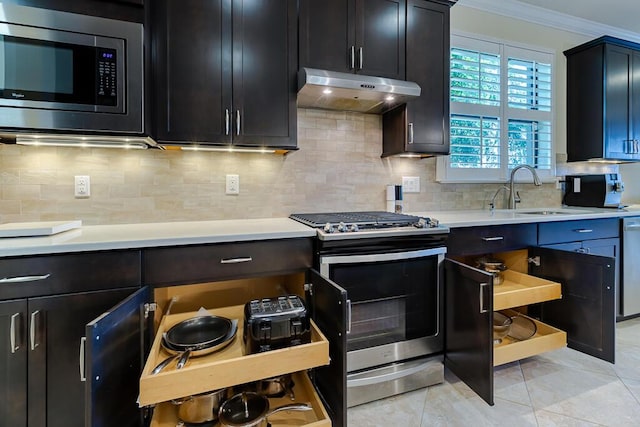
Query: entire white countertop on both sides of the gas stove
xmin=0 ymin=205 xmax=640 ymax=257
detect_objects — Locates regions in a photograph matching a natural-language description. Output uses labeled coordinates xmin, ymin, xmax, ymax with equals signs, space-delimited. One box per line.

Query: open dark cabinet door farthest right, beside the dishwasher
xmin=529 ymin=248 xmax=615 ymax=363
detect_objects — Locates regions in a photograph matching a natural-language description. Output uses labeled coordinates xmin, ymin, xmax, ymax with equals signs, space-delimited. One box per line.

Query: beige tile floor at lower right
xmin=348 ymin=319 xmax=640 ymax=427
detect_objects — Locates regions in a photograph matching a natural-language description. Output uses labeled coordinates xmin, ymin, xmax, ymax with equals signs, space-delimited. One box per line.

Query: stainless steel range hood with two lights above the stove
xmin=298 ymin=68 xmax=420 ymax=114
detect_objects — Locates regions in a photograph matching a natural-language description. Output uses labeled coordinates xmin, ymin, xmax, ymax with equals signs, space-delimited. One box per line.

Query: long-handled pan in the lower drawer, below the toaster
xmin=218 ymin=392 xmax=313 ymax=427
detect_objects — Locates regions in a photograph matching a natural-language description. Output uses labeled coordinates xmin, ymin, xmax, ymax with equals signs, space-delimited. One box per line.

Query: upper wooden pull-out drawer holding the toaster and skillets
xmin=139 ymin=305 xmax=329 ymax=406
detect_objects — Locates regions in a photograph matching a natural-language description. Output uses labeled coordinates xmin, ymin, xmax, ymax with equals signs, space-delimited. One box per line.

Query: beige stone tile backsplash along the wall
xmin=0 ymin=109 xmax=561 ymax=225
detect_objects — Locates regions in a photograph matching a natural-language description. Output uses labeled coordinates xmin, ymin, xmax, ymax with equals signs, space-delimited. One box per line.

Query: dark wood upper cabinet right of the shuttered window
xmin=564 ymin=37 xmax=640 ymax=161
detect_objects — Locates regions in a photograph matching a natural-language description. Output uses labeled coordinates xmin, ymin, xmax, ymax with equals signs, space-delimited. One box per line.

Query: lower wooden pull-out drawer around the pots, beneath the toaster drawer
xmin=151 ymin=371 xmax=331 ymax=427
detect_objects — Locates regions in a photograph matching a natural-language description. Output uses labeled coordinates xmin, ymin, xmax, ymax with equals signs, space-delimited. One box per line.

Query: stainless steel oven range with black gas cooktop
xmin=292 ymin=212 xmax=448 ymax=406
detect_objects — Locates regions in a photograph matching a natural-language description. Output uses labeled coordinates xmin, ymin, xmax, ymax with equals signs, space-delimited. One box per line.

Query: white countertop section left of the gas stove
xmin=0 ymin=218 xmax=316 ymax=257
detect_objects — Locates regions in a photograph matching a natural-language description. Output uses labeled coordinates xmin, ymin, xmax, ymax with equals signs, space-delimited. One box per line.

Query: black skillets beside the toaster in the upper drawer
xmin=151 ymin=315 xmax=238 ymax=374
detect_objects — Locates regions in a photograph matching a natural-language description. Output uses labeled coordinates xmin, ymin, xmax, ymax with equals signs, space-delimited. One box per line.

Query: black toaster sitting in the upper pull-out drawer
xmin=243 ymin=295 xmax=311 ymax=354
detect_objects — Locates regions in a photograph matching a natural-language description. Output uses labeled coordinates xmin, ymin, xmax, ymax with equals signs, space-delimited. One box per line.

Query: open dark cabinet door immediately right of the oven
xmin=444 ymin=259 xmax=493 ymax=405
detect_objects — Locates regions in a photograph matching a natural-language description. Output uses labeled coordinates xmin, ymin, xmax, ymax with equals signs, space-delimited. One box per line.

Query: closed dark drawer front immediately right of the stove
xmin=447 ymin=224 xmax=538 ymax=255
